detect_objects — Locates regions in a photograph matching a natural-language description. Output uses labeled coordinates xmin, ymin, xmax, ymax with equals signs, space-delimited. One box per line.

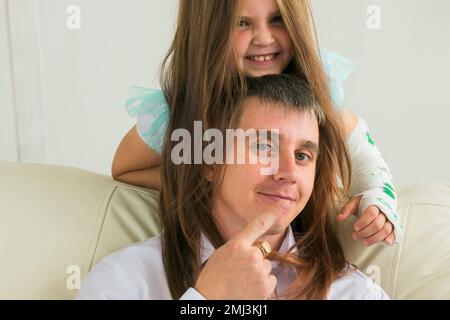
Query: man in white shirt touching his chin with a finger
xmin=78 ymin=75 xmax=387 ymax=300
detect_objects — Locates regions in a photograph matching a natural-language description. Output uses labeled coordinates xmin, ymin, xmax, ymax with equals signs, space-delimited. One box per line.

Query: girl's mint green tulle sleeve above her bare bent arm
xmin=125 ymin=87 xmax=169 ymax=154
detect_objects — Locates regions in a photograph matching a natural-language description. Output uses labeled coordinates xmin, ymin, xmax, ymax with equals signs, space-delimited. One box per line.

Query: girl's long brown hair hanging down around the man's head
xmin=160 ymin=0 xmax=350 ymax=299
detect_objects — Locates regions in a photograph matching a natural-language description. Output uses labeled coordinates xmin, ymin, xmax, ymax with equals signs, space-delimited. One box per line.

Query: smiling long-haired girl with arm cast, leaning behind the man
xmin=112 ymin=0 xmax=402 ymax=246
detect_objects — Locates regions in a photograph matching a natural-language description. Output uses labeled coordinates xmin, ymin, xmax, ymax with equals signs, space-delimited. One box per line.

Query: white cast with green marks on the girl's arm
xmin=348 ymin=118 xmax=403 ymax=244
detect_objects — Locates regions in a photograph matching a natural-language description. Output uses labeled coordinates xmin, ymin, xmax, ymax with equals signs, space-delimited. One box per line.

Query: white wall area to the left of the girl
xmin=0 ymin=0 xmax=177 ymax=174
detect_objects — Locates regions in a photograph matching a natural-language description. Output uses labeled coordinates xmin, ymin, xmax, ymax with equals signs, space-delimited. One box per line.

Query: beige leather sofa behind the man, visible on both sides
xmin=0 ymin=162 xmax=450 ymax=299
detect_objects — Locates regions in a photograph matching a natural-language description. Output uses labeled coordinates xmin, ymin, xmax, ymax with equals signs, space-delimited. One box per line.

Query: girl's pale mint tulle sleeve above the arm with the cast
xmin=320 ymin=49 xmax=356 ymax=109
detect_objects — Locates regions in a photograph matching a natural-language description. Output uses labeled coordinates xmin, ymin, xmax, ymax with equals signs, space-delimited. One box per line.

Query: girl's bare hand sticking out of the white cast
xmin=337 ymin=197 xmax=395 ymax=247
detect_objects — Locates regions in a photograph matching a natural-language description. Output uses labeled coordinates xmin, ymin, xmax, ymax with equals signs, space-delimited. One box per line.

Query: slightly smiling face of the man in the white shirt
xmin=213 ymin=97 xmax=319 ymax=239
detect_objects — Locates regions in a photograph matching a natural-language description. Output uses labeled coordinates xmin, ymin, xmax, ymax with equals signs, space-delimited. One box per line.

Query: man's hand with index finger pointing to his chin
xmin=195 ymin=213 xmax=277 ymax=300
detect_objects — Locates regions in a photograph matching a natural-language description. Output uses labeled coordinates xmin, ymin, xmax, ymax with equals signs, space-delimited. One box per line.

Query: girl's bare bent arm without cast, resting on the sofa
xmin=111 ymin=126 xmax=161 ymax=190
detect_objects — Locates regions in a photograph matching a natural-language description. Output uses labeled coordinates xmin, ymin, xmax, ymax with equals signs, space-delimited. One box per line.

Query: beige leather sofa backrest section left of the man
xmin=0 ymin=162 xmax=160 ymax=299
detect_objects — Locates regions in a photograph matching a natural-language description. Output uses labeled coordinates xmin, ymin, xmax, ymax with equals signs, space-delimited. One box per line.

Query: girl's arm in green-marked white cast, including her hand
xmin=338 ymin=108 xmax=402 ymax=245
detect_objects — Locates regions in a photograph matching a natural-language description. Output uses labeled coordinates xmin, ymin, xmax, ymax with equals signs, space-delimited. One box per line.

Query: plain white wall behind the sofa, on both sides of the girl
xmin=0 ymin=0 xmax=450 ymax=182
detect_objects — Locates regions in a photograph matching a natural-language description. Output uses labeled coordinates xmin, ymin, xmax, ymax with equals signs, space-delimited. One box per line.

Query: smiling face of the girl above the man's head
xmin=234 ymin=0 xmax=294 ymax=77
